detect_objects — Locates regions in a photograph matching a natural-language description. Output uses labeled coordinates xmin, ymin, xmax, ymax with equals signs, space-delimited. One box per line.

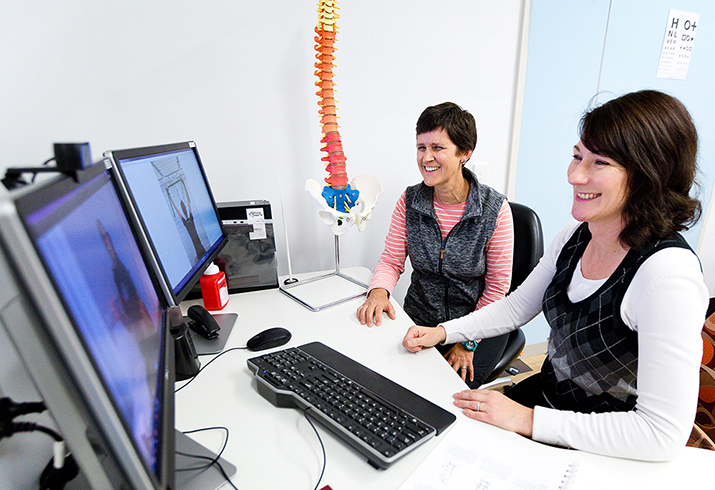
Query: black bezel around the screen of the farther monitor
xmin=104 ymin=141 xmax=228 ymax=306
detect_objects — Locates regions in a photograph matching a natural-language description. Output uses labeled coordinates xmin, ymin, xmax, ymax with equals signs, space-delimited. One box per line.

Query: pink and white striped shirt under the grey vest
xmin=369 ymin=192 xmax=514 ymax=310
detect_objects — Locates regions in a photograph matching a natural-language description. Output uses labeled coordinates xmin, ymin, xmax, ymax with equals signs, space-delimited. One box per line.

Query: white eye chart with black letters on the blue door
xmin=657 ymin=10 xmax=700 ymax=80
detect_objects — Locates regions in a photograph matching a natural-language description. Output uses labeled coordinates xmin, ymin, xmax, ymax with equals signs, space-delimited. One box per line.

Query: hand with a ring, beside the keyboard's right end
xmin=454 ymin=390 xmax=534 ymax=437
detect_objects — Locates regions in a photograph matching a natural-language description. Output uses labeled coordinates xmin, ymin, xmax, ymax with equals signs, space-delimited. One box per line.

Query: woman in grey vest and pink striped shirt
xmin=357 ymin=102 xmax=514 ymax=388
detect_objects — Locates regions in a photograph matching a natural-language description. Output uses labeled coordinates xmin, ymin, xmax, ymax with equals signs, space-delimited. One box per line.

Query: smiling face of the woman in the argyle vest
xmin=568 ymin=141 xmax=628 ymax=230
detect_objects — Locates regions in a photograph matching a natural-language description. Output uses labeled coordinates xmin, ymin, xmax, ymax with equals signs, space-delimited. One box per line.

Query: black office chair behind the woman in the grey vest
xmin=484 ymin=202 xmax=544 ymax=384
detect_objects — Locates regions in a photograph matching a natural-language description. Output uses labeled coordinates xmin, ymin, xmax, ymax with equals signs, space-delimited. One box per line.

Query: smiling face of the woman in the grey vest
xmin=417 ymin=129 xmax=472 ymax=191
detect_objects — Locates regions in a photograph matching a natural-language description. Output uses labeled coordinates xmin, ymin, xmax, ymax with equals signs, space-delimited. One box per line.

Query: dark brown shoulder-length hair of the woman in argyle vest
xmin=580 ymin=90 xmax=702 ymax=249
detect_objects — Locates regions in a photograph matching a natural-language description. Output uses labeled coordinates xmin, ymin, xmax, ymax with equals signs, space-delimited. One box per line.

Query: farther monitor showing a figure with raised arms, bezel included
xmin=105 ymin=142 xmax=227 ymax=305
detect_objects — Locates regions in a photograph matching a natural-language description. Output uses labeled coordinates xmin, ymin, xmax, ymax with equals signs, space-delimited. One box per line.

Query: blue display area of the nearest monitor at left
xmin=25 ymin=171 xmax=165 ymax=472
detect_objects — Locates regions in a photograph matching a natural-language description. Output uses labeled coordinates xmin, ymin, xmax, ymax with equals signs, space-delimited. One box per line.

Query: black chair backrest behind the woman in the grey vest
xmin=509 ymin=202 xmax=544 ymax=292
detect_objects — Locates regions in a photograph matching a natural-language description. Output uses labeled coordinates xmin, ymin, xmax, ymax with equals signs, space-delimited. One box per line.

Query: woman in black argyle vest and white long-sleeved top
xmin=403 ymin=90 xmax=708 ymax=461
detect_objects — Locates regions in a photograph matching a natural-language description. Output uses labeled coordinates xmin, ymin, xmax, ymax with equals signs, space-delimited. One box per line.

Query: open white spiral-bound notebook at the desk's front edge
xmin=400 ymin=420 xmax=579 ymax=490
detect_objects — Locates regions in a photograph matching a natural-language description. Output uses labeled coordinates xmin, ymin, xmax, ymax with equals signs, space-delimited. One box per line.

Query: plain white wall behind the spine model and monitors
xmin=0 ymin=0 xmax=521 ymax=306
